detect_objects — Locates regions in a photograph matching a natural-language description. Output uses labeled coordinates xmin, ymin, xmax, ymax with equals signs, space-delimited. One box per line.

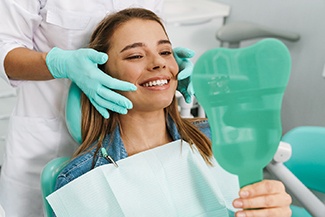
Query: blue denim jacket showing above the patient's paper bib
xmin=55 ymin=117 xmax=211 ymax=189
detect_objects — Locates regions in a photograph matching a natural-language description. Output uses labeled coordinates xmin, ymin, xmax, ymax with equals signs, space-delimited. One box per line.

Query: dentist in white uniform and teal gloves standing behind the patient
xmin=0 ymin=0 xmax=194 ymax=217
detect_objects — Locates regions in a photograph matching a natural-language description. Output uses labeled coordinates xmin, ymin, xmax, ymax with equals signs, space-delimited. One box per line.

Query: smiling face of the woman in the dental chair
xmin=106 ymin=19 xmax=178 ymax=112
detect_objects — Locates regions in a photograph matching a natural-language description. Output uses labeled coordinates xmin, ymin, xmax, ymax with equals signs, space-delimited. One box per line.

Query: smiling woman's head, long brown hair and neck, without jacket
xmin=71 ymin=9 xmax=212 ymax=161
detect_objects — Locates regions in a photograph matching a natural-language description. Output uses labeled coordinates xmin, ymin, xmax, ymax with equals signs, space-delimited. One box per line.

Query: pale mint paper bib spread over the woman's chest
xmin=47 ymin=140 xmax=239 ymax=217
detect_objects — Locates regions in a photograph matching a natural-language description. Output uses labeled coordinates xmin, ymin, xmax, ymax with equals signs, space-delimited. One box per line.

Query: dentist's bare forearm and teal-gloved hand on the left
xmin=5 ymin=48 xmax=136 ymax=118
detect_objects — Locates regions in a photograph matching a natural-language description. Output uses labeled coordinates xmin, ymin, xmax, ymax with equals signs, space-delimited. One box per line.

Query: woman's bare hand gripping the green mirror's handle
xmin=233 ymin=180 xmax=292 ymax=217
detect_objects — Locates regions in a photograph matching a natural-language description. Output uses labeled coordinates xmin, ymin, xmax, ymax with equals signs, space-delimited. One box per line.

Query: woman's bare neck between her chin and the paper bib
xmin=119 ymin=111 xmax=172 ymax=156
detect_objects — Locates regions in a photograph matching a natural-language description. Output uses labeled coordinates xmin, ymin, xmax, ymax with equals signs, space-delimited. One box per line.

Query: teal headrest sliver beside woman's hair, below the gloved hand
xmin=65 ymin=82 xmax=82 ymax=144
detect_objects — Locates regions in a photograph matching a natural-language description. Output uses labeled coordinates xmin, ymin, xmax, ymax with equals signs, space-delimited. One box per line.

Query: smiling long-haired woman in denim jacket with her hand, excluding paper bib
xmin=53 ymin=9 xmax=291 ymax=217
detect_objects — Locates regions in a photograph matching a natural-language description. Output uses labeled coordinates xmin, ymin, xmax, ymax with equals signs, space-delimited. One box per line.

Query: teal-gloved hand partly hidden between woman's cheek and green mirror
xmin=173 ymin=47 xmax=195 ymax=103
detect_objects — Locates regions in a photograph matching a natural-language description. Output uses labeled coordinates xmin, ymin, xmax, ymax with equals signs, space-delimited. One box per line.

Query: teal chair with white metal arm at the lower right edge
xmin=266 ymin=126 xmax=325 ymax=217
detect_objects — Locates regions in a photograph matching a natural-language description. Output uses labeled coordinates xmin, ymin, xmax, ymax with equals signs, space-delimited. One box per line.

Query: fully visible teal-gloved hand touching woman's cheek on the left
xmin=46 ymin=47 xmax=136 ymax=118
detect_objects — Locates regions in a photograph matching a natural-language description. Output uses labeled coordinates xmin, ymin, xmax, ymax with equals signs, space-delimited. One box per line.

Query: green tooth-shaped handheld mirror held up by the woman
xmin=192 ymin=39 xmax=291 ymax=187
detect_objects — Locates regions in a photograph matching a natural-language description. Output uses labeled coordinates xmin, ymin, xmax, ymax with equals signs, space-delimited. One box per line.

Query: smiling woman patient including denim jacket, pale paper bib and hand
xmin=49 ymin=8 xmax=289 ymax=216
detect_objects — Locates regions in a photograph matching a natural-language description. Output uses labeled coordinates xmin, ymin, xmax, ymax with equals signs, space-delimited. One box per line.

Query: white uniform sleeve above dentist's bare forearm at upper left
xmin=0 ymin=0 xmax=43 ymax=85
